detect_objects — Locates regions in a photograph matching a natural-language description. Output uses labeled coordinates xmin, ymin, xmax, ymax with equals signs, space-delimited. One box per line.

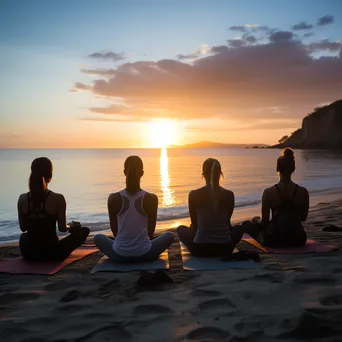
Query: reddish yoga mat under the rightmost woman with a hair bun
xmin=242 ymin=234 xmax=338 ymax=254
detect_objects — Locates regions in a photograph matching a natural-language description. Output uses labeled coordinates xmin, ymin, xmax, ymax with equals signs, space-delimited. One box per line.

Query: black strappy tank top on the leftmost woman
xmin=24 ymin=191 xmax=58 ymax=244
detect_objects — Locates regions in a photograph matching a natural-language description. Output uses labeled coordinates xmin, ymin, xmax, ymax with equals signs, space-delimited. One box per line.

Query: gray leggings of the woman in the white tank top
xmin=94 ymin=232 xmax=174 ymax=263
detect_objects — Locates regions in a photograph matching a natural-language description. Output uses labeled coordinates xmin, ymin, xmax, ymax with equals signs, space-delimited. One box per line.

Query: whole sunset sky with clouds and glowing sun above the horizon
xmin=0 ymin=0 xmax=342 ymax=148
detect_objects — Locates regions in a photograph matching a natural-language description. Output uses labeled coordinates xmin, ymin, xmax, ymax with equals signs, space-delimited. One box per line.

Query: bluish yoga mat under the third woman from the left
xmin=180 ymin=242 xmax=257 ymax=271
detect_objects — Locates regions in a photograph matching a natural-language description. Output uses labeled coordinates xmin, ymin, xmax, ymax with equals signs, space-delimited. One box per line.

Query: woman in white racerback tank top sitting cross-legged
xmin=94 ymin=156 xmax=174 ymax=263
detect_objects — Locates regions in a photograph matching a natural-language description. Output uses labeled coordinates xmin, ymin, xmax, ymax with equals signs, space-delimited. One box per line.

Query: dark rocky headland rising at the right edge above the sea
xmin=273 ymin=100 xmax=342 ymax=149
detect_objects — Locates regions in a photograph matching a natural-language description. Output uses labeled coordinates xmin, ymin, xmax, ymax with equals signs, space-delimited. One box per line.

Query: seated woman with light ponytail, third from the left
xmin=177 ymin=158 xmax=243 ymax=256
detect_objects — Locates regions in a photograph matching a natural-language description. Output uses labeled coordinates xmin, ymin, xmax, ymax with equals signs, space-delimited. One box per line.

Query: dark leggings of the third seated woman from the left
xmin=177 ymin=226 xmax=243 ymax=257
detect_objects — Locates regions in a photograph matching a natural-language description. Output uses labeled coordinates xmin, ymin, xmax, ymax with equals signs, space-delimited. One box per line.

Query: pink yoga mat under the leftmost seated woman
xmin=0 ymin=247 xmax=98 ymax=275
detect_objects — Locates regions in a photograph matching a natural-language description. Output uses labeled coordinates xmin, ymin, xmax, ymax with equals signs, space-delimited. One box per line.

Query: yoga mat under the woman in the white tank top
xmin=91 ymin=251 xmax=169 ymax=273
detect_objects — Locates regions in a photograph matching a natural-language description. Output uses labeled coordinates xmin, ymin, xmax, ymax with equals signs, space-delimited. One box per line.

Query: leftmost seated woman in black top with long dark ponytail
xmin=18 ymin=157 xmax=89 ymax=261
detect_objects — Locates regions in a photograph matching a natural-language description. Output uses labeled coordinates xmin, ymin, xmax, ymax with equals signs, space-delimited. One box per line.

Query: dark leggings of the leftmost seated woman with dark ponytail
xmin=19 ymin=227 xmax=90 ymax=261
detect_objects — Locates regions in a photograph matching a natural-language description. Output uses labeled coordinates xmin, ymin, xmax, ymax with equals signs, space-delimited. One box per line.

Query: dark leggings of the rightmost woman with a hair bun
xmin=242 ymin=221 xmax=307 ymax=248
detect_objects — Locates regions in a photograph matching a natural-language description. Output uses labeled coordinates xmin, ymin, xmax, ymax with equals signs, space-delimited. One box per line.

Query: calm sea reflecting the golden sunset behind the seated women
xmin=0 ymin=149 xmax=342 ymax=241
